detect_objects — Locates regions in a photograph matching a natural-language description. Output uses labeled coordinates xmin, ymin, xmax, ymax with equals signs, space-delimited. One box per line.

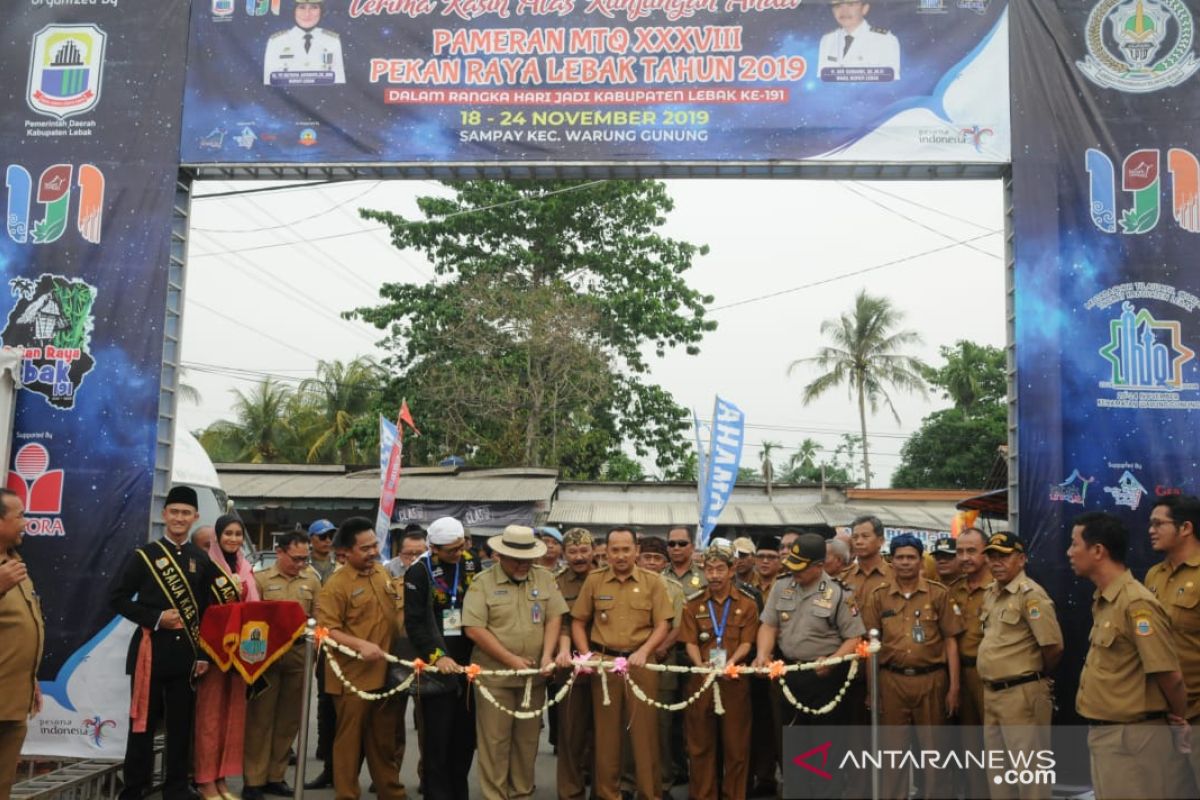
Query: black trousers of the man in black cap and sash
xmin=120 ymin=672 xmax=196 ymax=800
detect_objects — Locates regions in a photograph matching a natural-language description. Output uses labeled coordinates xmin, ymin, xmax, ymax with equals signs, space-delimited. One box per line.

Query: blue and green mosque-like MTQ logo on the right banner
xmin=1085 ymin=281 xmax=1200 ymax=410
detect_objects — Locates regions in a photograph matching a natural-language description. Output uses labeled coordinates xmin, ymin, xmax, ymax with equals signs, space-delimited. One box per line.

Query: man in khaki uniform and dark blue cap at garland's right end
xmin=863 ymin=534 xmax=962 ymax=798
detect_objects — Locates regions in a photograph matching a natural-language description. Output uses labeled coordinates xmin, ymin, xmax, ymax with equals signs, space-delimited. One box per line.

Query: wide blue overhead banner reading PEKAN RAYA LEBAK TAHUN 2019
xmin=182 ymin=0 xmax=1009 ymax=164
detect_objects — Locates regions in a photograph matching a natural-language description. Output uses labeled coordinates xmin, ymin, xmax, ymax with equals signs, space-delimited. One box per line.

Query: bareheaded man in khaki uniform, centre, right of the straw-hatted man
xmin=571 ymin=528 xmax=673 ymax=800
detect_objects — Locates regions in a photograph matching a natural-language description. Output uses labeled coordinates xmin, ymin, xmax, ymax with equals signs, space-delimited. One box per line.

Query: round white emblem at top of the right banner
xmin=1075 ymin=0 xmax=1200 ymax=94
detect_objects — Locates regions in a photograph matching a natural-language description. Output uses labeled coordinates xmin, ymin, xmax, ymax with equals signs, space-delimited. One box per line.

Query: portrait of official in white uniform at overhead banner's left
xmin=263 ymin=0 xmax=346 ymax=86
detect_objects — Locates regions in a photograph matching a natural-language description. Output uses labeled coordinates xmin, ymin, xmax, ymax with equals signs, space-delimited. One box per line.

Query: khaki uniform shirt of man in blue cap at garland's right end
xmin=863 ymin=577 xmax=962 ymax=668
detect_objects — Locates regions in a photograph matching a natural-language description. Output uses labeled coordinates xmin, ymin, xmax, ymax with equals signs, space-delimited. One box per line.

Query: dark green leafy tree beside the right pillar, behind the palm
xmin=892 ymin=341 xmax=1008 ymax=489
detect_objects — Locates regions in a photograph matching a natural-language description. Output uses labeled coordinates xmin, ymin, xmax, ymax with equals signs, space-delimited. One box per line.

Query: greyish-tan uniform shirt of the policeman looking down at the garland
xmin=761 ymin=577 xmax=866 ymax=662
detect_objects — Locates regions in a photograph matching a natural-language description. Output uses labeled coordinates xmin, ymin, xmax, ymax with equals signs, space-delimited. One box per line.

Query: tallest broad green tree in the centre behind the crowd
xmin=350 ymin=181 xmax=716 ymax=477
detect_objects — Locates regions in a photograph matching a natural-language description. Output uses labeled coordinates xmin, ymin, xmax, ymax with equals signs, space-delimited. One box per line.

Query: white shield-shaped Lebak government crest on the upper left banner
xmin=25 ymin=25 xmax=108 ymax=120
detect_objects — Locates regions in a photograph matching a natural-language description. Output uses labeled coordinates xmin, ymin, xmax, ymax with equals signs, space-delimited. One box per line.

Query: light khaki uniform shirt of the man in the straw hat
xmin=462 ymin=564 xmax=566 ymax=686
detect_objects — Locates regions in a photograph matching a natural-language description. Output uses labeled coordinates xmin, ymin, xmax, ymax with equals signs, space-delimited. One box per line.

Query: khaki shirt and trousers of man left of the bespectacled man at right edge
xmin=1089 ymin=570 xmax=1180 ymax=800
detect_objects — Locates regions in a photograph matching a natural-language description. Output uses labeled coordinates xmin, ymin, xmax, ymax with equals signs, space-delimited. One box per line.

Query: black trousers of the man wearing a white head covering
xmin=418 ymin=678 xmax=475 ymax=800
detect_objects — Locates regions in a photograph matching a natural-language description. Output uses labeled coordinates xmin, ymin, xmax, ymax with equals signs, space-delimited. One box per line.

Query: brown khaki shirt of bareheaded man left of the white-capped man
xmin=317 ymin=564 xmax=404 ymax=694
